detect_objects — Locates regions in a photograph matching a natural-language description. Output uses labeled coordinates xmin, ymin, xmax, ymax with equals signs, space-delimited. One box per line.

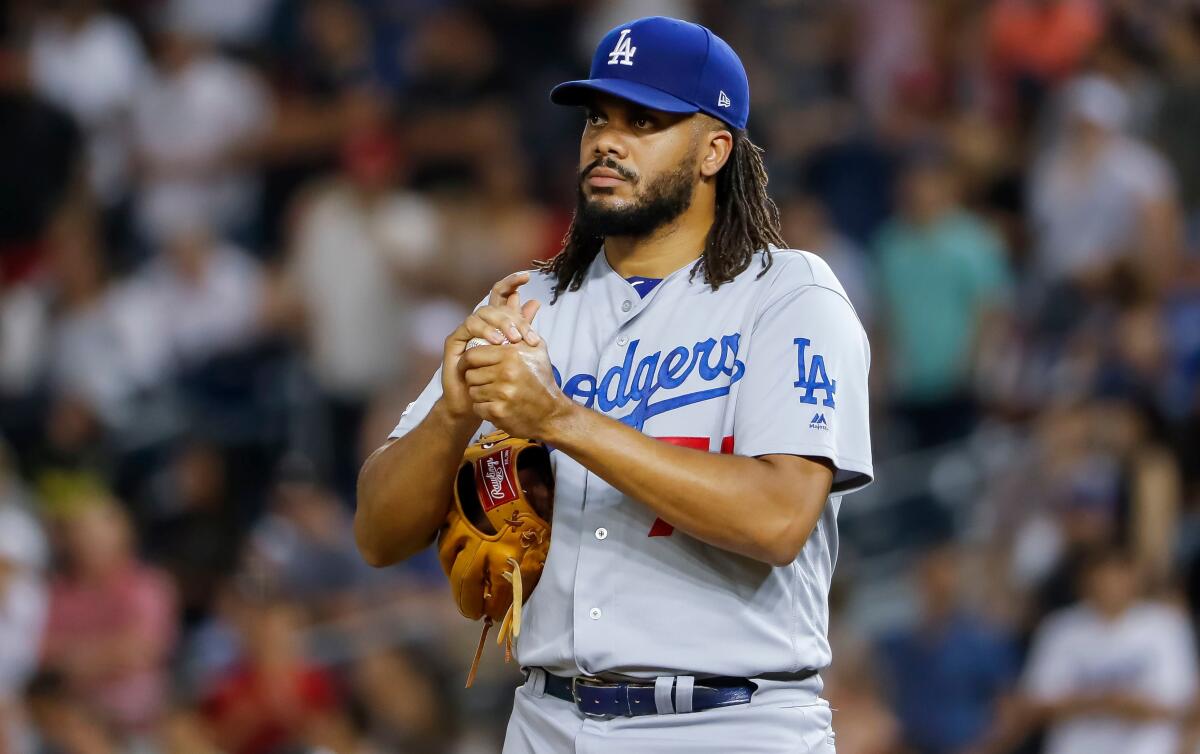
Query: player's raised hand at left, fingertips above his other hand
xmin=442 ymin=273 xmax=541 ymax=420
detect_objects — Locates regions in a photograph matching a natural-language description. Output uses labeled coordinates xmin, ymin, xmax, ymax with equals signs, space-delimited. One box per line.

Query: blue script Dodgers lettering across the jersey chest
xmin=554 ymin=333 xmax=746 ymax=430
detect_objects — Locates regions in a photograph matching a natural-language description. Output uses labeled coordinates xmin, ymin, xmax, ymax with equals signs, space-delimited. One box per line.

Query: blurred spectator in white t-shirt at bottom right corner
xmin=1022 ymin=549 xmax=1196 ymax=754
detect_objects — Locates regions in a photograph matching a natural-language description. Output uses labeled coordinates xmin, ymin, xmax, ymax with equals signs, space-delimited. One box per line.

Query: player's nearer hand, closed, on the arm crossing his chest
xmin=458 ymin=338 xmax=576 ymax=439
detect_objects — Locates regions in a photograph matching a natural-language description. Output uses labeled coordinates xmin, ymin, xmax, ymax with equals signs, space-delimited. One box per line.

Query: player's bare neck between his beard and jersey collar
xmin=604 ymin=197 xmax=714 ymax=277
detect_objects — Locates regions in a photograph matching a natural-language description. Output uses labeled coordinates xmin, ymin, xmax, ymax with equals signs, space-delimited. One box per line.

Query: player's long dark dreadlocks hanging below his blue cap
xmin=534 ymin=128 xmax=785 ymax=301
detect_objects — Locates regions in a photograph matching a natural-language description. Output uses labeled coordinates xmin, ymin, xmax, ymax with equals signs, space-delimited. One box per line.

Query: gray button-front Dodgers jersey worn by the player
xmin=392 ymin=249 xmax=872 ymax=677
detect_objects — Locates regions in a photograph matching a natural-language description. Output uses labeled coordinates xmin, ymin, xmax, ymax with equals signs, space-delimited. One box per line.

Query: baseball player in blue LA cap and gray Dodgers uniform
xmin=355 ymin=17 xmax=872 ymax=754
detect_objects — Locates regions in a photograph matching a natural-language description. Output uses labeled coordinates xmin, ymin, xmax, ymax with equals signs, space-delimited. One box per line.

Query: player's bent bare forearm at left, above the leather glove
xmin=354 ymin=401 xmax=480 ymax=567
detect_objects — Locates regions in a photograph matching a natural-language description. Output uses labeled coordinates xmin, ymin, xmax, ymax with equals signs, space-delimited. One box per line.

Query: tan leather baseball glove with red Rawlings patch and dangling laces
xmin=438 ymin=431 xmax=554 ymax=687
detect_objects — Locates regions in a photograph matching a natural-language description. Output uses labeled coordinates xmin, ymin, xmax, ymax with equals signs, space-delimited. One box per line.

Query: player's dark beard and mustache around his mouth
xmin=575 ymin=162 xmax=695 ymax=238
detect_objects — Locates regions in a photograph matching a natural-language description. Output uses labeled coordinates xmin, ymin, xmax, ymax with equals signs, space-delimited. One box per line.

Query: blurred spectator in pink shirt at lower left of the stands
xmin=43 ymin=497 xmax=176 ymax=734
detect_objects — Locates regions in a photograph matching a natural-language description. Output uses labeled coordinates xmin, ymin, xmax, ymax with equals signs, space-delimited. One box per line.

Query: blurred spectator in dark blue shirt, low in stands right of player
xmin=877 ymin=546 xmax=1018 ymax=754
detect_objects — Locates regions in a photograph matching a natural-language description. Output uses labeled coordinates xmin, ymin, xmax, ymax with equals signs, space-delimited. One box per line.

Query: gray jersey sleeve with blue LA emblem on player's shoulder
xmin=733 ymin=285 xmax=874 ymax=493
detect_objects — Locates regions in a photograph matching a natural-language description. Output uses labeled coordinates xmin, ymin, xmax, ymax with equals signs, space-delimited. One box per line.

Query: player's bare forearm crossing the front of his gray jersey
xmin=545 ymin=403 xmax=833 ymax=566
